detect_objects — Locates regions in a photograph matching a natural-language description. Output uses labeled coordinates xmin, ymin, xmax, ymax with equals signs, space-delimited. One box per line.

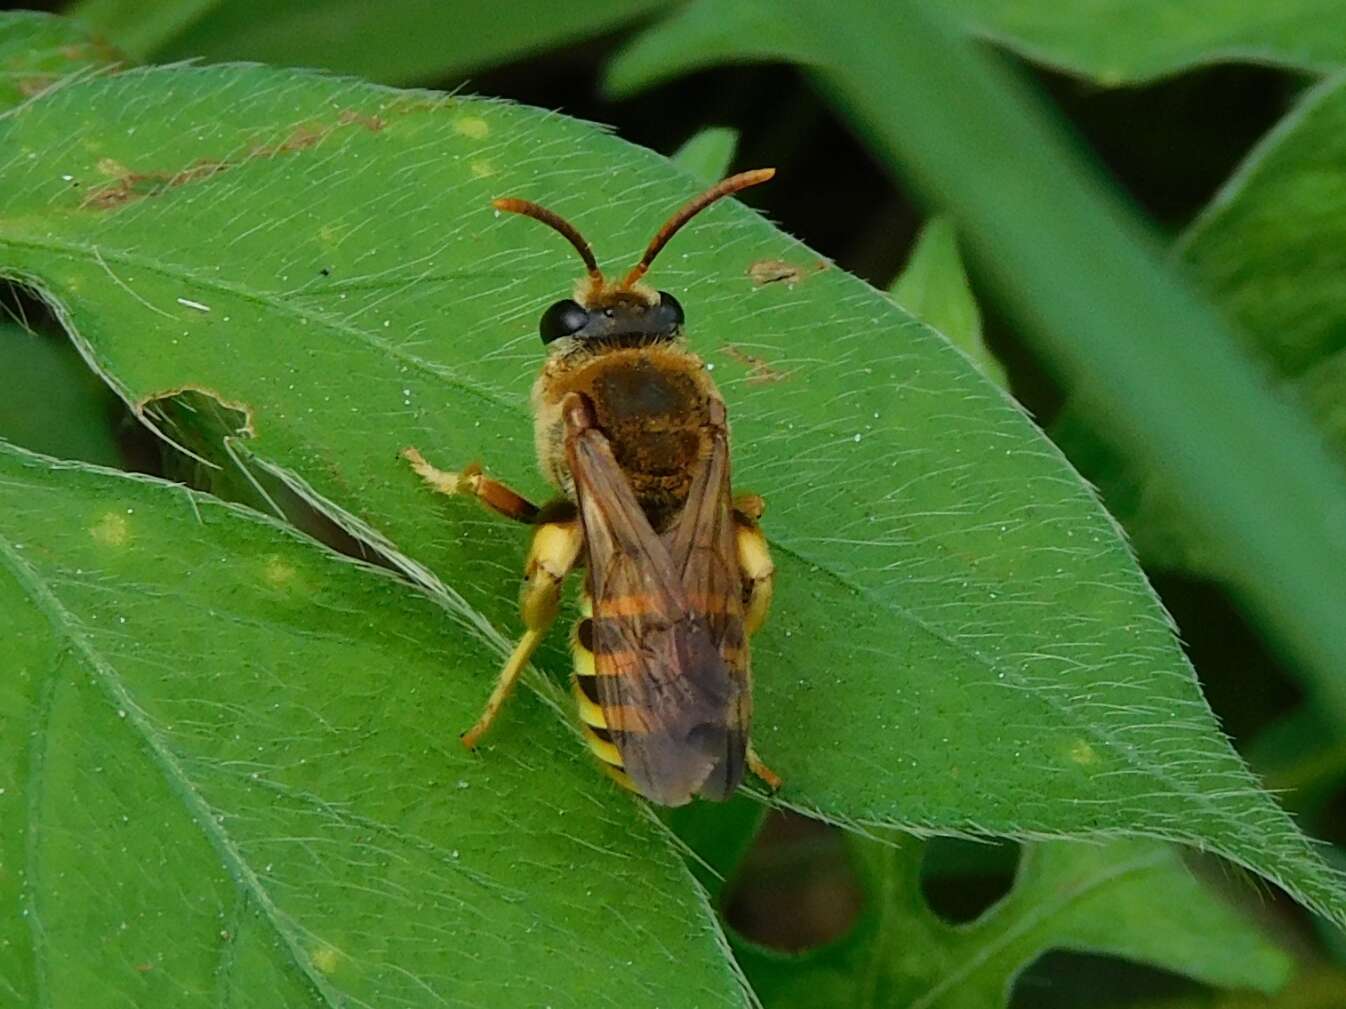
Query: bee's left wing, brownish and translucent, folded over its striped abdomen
xmin=565 ymin=402 xmax=742 ymax=806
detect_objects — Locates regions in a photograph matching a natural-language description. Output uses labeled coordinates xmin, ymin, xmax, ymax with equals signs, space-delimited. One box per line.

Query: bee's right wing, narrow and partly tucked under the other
xmin=664 ymin=402 xmax=752 ymax=799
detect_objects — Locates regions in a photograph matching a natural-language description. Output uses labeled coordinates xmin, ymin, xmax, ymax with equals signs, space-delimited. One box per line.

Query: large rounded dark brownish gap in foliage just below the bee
xmin=724 ymin=813 xmax=863 ymax=952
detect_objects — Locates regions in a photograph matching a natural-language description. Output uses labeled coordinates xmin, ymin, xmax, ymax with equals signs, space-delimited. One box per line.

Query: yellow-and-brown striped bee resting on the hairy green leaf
xmin=402 ymin=168 xmax=781 ymax=806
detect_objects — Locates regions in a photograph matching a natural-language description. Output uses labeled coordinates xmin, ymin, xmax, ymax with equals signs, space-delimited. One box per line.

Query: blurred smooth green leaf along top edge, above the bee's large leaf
xmin=75 ymin=0 xmax=669 ymax=83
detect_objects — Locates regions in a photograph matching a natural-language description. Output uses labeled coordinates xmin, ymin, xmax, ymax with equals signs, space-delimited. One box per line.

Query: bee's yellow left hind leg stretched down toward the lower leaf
xmin=462 ymin=519 xmax=584 ymax=749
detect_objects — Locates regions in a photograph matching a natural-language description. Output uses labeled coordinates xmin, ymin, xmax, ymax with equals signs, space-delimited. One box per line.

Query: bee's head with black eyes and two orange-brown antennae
xmin=493 ymin=168 xmax=775 ymax=352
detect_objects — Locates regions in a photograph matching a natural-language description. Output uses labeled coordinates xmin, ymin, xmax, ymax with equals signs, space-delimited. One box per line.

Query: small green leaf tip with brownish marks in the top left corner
xmin=0 ymin=11 xmax=120 ymax=113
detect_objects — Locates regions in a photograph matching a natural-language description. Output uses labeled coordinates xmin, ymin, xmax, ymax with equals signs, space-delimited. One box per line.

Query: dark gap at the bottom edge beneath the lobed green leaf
xmin=1010 ymin=950 xmax=1210 ymax=1009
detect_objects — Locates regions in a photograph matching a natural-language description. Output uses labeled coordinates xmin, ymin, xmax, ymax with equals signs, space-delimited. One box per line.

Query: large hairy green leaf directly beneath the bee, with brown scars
xmin=0 ymin=49 xmax=1346 ymax=941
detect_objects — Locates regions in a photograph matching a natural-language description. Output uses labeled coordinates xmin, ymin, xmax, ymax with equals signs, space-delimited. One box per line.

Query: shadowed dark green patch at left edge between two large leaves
xmin=0 ymin=281 xmax=141 ymax=470
